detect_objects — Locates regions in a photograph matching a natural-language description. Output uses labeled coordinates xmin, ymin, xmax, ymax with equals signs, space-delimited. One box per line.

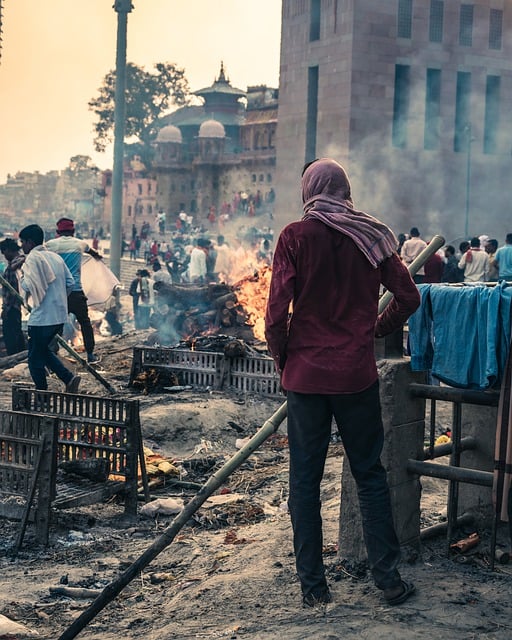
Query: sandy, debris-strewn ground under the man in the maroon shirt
xmin=0 ymin=332 xmax=512 ymax=640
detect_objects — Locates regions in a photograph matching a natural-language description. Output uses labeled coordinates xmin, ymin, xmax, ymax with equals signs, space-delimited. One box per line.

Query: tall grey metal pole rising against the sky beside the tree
xmin=110 ymin=0 xmax=133 ymax=278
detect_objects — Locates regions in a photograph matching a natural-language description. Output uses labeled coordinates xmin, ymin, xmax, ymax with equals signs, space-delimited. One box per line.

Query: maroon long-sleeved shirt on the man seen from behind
xmin=265 ymin=220 xmax=420 ymax=394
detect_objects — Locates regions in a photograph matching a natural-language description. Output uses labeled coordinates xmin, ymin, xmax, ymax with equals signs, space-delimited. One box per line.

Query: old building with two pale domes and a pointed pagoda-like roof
xmin=152 ymin=64 xmax=278 ymax=226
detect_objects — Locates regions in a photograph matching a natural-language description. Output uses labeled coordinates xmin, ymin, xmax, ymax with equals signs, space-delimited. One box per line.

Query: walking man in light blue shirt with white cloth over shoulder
xmin=19 ymin=224 xmax=80 ymax=393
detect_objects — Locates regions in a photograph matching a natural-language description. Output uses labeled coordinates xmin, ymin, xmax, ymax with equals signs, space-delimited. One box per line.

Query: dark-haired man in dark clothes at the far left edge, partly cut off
xmin=0 ymin=238 xmax=26 ymax=355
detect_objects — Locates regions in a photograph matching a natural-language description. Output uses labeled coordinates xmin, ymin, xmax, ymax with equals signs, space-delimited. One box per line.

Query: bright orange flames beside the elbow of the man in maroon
xmin=234 ymin=264 xmax=272 ymax=341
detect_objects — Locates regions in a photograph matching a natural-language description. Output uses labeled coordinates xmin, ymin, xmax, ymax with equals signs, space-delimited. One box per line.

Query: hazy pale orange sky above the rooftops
xmin=0 ymin=0 xmax=281 ymax=184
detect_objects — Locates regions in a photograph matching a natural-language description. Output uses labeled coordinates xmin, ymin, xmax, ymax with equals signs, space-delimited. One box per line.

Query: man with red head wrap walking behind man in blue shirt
xmin=46 ymin=218 xmax=101 ymax=363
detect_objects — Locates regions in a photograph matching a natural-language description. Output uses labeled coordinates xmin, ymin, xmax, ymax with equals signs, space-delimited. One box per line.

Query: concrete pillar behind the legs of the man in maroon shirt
xmin=338 ymin=358 xmax=425 ymax=564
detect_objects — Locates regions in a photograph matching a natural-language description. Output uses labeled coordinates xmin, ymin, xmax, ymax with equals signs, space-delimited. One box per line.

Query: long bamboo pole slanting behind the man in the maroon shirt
xmin=58 ymin=236 xmax=445 ymax=640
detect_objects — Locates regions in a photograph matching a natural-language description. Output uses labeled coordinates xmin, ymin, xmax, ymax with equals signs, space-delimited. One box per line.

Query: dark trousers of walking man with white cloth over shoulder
xmin=28 ymin=324 xmax=73 ymax=389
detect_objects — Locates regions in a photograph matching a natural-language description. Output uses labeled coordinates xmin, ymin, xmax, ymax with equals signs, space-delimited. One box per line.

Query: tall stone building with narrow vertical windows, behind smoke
xmin=275 ymin=0 xmax=512 ymax=240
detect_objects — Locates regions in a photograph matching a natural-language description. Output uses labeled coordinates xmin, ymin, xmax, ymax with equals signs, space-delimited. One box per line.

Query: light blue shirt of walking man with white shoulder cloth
xmin=21 ymin=251 xmax=75 ymax=327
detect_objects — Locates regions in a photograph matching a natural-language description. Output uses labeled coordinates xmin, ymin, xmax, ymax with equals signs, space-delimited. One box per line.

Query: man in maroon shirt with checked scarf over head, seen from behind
xmin=265 ymin=158 xmax=420 ymax=606
